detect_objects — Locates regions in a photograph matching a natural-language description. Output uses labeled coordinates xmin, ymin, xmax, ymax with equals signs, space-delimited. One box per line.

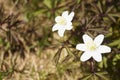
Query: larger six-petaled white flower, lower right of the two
xmin=76 ymin=34 xmax=111 ymax=62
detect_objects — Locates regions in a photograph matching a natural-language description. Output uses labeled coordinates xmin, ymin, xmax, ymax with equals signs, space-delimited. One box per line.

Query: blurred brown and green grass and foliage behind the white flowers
xmin=0 ymin=0 xmax=120 ymax=80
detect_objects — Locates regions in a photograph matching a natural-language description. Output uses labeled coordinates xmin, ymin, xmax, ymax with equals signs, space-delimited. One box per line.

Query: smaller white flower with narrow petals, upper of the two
xmin=52 ymin=11 xmax=74 ymax=37
